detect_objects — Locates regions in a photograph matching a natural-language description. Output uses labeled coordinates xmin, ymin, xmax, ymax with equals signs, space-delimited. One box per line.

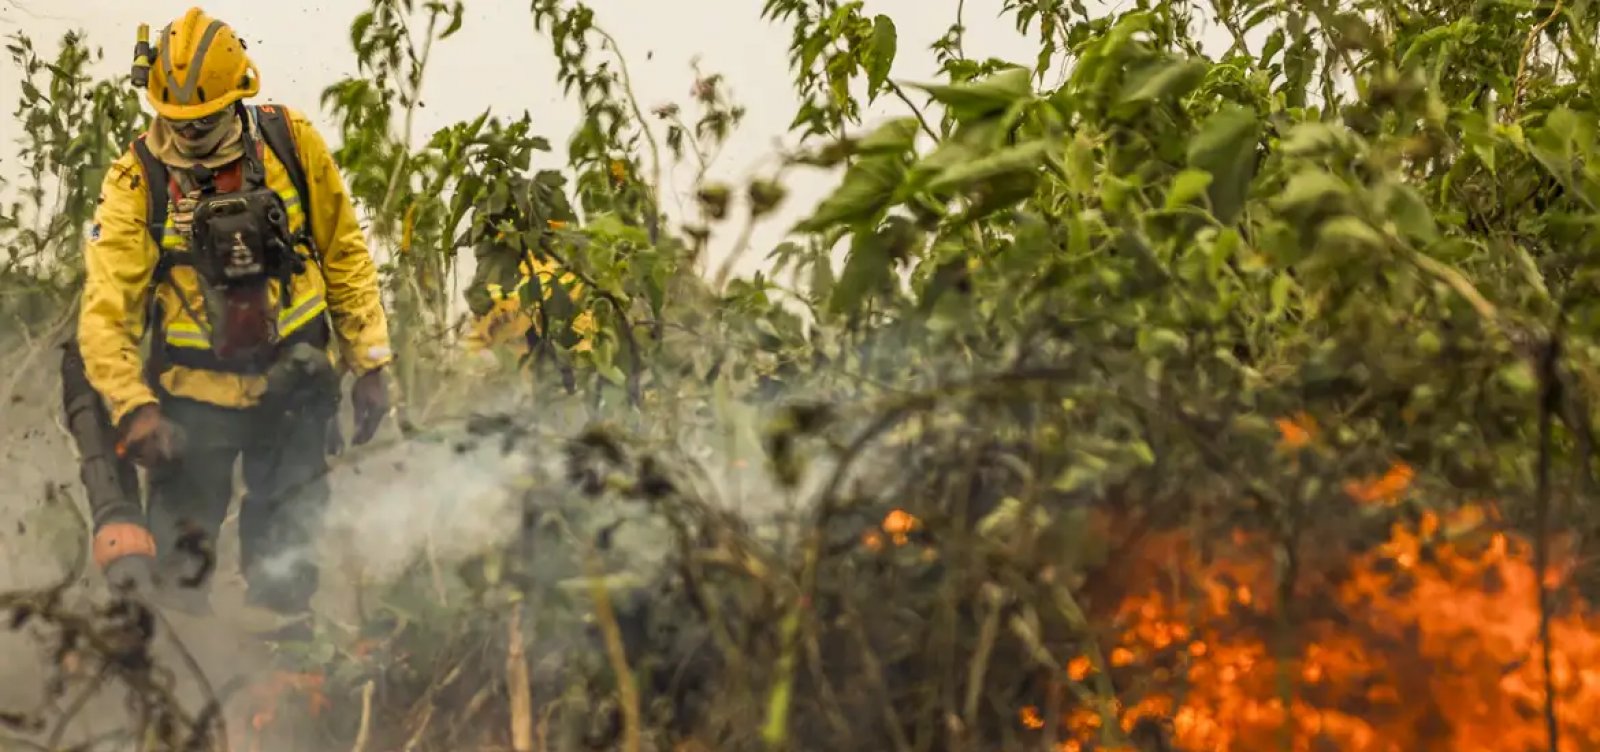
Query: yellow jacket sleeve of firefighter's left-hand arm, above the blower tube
xmin=77 ymin=154 xmax=157 ymax=426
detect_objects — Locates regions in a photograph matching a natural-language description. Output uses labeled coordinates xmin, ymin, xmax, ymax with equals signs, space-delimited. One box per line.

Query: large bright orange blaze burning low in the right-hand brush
xmin=1021 ymin=421 xmax=1600 ymax=752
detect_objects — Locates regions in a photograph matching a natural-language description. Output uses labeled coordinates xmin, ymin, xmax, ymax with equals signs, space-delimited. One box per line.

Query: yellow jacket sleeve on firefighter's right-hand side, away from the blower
xmin=288 ymin=109 xmax=394 ymax=374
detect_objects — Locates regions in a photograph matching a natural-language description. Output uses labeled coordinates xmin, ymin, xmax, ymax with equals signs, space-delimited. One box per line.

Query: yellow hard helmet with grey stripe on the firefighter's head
xmin=146 ymin=8 xmax=261 ymax=120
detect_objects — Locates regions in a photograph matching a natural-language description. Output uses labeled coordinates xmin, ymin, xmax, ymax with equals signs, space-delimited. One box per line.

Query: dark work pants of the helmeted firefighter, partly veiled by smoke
xmin=146 ymin=390 xmax=331 ymax=613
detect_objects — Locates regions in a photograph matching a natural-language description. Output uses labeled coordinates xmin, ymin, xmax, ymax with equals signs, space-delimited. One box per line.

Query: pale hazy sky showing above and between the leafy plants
xmin=0 ymin=0 xmax=1035 ymax=296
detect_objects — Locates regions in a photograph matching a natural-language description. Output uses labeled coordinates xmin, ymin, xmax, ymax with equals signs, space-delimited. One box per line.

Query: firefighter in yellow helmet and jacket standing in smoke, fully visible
xmin=77 ymin=8 xmax=392 ymax=635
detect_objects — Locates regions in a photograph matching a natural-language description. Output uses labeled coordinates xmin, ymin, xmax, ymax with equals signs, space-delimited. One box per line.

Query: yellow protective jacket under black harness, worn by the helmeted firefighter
xmin=77 ymin=107 xmax=392 ymax=426
